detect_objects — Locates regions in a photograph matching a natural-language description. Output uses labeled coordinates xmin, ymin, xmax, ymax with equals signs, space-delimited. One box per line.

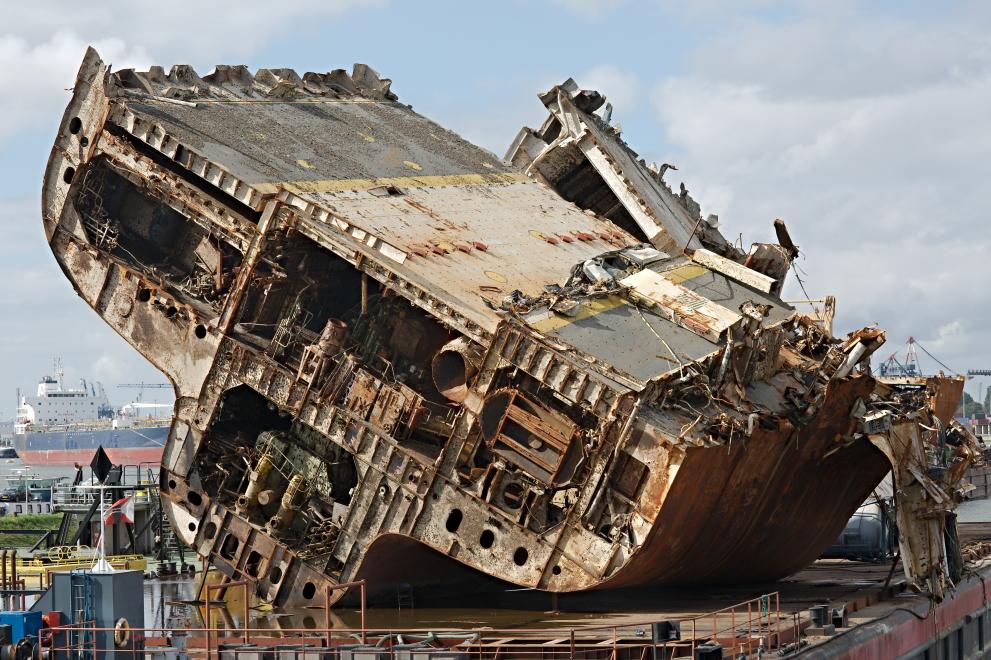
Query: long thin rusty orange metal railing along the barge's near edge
xmin=35 ymin=592 xmax=797 ymax=660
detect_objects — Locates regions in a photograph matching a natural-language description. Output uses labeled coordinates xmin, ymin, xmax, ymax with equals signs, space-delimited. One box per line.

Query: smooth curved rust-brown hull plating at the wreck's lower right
xmin=603 ymin=382 xmax=891 ymax=587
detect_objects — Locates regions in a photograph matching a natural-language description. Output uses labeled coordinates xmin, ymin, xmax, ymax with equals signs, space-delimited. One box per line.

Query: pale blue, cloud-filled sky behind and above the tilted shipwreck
xmin=0 ymin=0 xmax=991 ymax=417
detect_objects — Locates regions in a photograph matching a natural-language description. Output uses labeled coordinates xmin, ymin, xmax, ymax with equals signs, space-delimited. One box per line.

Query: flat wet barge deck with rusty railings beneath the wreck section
xmin=19 ymin=523 xmax=991 ymax=660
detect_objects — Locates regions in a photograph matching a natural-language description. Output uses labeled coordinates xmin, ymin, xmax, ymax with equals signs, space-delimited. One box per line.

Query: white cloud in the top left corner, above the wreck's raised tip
xmin=0 ymin=0 xmax=386 ymax=149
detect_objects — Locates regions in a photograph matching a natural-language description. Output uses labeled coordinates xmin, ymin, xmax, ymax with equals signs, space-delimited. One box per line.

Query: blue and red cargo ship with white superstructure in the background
xmin=13 ymin=366 xmax=172 ymax=466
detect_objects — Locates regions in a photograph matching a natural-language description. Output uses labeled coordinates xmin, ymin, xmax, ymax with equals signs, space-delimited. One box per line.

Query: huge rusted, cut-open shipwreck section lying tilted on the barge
xmin=43 ymin=50 xmax=966 ymax=605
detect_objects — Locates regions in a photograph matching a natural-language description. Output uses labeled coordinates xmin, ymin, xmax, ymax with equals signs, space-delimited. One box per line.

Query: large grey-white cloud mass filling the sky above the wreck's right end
xmin=654 ymin=7 xmax=991 ymax=386
